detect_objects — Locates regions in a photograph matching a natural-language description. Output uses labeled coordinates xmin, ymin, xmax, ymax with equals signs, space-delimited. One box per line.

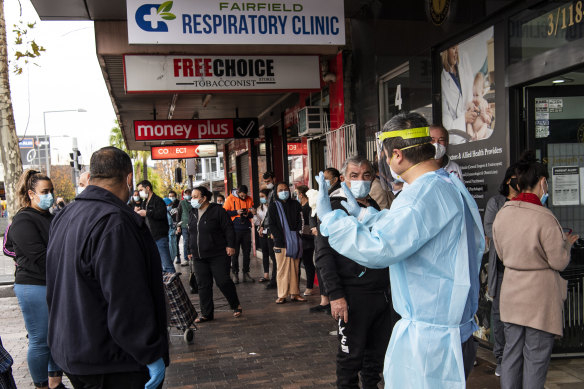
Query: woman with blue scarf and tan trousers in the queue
xmin=268 ymin=182 xmax=307 ymax=304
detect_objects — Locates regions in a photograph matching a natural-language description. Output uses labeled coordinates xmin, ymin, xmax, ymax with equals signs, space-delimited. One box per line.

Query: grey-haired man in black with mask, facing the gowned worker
xmin=316 ymin=156 xmax=395 ymax=388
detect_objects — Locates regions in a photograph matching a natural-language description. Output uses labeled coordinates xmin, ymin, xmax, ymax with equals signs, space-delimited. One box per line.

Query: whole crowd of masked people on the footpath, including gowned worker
xmin=4 ymin=126 xmax=579 ymax=389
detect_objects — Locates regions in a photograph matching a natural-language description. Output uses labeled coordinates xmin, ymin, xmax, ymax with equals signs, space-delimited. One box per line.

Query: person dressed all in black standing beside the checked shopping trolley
xmin=188 ymin=186 xmax=242 ymax=323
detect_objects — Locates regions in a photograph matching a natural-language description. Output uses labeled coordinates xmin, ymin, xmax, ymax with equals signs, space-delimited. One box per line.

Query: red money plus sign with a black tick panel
xmin=134 ymin=118 xmax=259 ymax=141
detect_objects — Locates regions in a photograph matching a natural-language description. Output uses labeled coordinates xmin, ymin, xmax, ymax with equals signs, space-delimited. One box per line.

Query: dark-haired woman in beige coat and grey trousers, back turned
xmin=493 ymin=152 xmax=578 ymax=389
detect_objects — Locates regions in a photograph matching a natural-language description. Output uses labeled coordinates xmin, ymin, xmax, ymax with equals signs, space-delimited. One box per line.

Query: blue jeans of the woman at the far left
xmin=14 ymin=284 xmax=61 ymax=386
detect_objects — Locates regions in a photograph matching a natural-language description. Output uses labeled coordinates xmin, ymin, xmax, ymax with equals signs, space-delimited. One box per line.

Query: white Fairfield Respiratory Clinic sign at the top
xmin=126 ymin=0 xmax=345 ymax=46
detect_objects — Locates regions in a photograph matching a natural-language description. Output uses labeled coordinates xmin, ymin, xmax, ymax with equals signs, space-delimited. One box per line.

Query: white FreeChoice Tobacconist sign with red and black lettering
xmin=124 ymin=55 xmax=320 ymax=93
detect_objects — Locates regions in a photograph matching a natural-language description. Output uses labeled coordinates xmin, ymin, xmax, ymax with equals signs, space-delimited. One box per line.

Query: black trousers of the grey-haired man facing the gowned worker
xmin=337 ymin=290 xmax=397 ymax=389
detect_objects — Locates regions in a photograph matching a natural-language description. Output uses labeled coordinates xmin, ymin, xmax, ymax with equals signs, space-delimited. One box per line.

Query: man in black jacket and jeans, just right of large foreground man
xmin=134 ymin=180 xmax=175 ymax=273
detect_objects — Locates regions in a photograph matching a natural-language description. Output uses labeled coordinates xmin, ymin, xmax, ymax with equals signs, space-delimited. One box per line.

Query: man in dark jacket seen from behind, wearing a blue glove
xmin=47 ymin=147 xmax=169 ymax=389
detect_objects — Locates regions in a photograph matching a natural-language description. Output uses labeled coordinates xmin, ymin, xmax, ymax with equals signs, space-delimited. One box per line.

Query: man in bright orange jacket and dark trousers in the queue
xmin=223 ymin=185 xmax=255 ymax=284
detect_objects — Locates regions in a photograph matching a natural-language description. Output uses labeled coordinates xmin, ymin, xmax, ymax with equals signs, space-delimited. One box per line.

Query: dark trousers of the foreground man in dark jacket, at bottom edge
xmin=67 ymin=372 xmax=162 ymax=389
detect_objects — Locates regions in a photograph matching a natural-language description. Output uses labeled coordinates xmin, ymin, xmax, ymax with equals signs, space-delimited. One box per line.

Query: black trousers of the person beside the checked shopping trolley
xmin=193 ymin=254 xmax=239 ymax=319
